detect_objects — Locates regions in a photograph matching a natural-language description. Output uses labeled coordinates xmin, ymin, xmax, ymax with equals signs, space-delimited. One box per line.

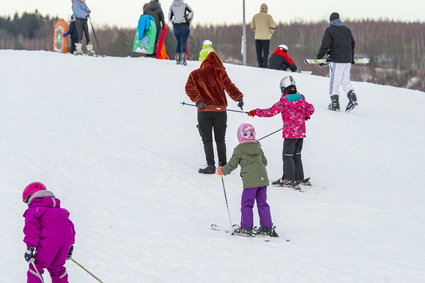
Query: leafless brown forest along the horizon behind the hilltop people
xmin=0 ymin=11 xmax=425 ymax=91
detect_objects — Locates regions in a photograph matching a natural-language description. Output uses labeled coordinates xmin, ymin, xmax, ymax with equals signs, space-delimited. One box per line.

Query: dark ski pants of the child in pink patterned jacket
xmin=282 ymin=139 xmax=304 ymax=181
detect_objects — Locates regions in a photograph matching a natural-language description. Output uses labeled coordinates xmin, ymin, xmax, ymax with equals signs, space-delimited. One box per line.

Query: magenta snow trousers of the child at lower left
xmin=27 ymin=245 xmax=71 ymax=283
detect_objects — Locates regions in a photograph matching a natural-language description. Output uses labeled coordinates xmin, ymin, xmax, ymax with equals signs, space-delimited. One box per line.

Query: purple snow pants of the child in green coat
xmin=241 ymin=186 xmax=273 ymax=228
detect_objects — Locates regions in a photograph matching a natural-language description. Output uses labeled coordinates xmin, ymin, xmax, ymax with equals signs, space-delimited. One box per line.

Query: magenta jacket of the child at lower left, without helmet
xmin=24 ymin=190 xmax=75 ymax=252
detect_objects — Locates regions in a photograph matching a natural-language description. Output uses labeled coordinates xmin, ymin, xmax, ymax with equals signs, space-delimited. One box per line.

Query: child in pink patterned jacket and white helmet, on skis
xmin=248 ymin=76 xmax=314 ymax=190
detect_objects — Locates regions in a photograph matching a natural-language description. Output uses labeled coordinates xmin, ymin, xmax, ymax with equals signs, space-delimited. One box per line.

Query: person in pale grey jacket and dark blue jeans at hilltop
xmin=168 ymin=0 xmax=193 ymax=65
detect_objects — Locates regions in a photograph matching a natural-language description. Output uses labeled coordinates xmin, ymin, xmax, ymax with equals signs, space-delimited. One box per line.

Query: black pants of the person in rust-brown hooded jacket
xmin=197 ymin=111 xmax=227 ymax=166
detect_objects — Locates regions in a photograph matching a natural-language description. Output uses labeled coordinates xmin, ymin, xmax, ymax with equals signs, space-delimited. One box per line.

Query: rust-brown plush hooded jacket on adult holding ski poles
xmin=185 ymin=52 xmax=243 ymax=111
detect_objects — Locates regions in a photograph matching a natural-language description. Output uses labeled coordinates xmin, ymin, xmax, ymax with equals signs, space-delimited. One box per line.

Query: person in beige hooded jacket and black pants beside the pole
xmin=251 ymin=3 xmax=276 ymax=68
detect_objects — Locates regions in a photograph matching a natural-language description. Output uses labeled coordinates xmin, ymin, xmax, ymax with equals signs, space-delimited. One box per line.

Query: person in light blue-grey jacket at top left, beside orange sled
xmin=72 ymin=0 xmax=94 ymax=55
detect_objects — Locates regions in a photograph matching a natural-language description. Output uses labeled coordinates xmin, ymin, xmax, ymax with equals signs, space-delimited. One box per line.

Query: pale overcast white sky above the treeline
xmin=0 ymin=0 xmax=425 ymax=27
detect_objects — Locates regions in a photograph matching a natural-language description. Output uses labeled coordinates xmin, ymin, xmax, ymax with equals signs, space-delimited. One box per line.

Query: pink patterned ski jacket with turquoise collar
xmin=256 ymin=93 xmax=314 ymax=139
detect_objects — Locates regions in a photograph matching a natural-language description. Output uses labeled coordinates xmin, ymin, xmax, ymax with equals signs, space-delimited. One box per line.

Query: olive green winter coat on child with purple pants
xmin=222 ymin=141 xmax=269 ymax=189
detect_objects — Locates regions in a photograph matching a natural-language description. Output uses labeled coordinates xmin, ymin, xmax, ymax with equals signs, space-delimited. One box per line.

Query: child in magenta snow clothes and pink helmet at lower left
xmin=22 ymin=182 xmax=75 ymax=283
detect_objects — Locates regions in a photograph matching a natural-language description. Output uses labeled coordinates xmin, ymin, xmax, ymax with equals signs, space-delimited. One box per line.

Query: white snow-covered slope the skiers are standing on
xmin=0 ymin=50 xmax=425 ymax=283
